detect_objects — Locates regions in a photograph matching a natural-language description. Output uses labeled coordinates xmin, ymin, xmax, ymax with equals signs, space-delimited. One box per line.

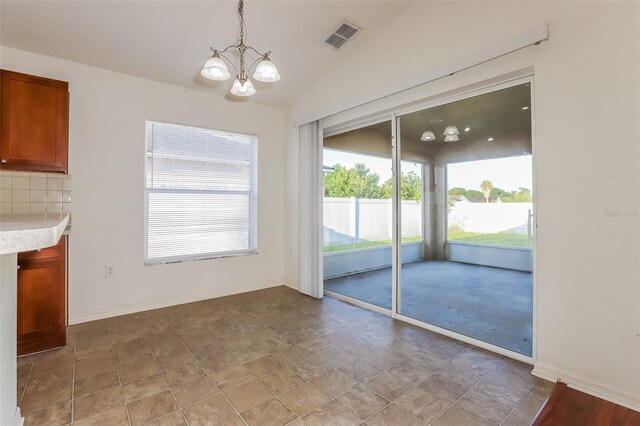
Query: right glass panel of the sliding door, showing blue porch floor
xmin=397 ymin=83 xmax=533 ymax=356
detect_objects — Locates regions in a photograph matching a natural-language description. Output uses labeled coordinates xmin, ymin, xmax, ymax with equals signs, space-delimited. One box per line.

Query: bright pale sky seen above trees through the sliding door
xmin=323 ymin=148 xmax=533 ymax=191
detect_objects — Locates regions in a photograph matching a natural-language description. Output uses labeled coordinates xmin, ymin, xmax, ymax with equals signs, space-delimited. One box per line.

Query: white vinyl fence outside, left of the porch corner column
xmin=323 ymin=197 xmax=422 ymax=246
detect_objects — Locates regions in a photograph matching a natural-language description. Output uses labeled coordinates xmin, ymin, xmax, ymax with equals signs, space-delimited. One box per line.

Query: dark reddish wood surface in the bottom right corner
xmin=532 ymin=383 xmax=640 ymax=426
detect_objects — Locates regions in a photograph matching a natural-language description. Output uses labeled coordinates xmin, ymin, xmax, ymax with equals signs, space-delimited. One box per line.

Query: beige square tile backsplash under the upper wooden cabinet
xmin=0 ymin=170 xmax=71 ymax=213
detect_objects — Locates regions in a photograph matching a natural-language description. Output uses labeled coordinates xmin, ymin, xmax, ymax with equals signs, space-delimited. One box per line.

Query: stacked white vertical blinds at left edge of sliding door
xmin=298 ymin=121 xmax=323 ymax=299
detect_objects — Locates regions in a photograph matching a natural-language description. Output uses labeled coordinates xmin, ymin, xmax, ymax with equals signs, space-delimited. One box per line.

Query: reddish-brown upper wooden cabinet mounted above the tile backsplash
xmin=0 ymin=70 xmax=69 ymax=173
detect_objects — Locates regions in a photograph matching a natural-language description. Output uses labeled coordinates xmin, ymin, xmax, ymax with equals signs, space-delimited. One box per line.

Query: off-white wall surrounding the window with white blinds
xmin=0 ymin=47 xmax=286 ymax=323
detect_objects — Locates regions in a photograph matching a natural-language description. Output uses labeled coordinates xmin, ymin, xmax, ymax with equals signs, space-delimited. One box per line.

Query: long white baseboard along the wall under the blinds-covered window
xmin=69 ymin=283 xmax=286 ymax=325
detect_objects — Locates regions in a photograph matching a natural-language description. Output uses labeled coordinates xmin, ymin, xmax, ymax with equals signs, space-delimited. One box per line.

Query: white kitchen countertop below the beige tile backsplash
xmin=0 ymin=213 xmax=69 ymax=255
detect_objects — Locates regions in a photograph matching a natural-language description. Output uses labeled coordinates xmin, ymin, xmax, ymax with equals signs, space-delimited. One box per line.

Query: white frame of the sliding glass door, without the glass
xmin=319 ymin=71 xmax=538 ymax=365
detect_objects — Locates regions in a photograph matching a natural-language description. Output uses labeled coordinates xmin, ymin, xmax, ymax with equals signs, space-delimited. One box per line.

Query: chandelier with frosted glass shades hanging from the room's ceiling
xmin=200 ymin=0 xmax=280 ymax=96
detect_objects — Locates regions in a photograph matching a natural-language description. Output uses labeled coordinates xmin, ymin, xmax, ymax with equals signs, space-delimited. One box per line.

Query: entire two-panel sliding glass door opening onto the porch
xmin=323 ymin=82 xmax=535 ymax=358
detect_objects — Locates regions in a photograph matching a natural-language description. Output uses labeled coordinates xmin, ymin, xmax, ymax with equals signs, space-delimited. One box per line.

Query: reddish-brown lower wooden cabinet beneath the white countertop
xmin=18 ymin=236 xmax=67 ymax=355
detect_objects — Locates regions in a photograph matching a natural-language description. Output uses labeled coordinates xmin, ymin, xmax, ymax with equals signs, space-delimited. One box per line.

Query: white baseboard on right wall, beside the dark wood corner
xmin=531 ymin=363 xmax=640 ymax=411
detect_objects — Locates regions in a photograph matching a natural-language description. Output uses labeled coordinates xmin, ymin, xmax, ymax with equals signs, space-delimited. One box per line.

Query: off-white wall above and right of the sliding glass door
xmin=286 ymin=2 xmax=640 ymax=407
